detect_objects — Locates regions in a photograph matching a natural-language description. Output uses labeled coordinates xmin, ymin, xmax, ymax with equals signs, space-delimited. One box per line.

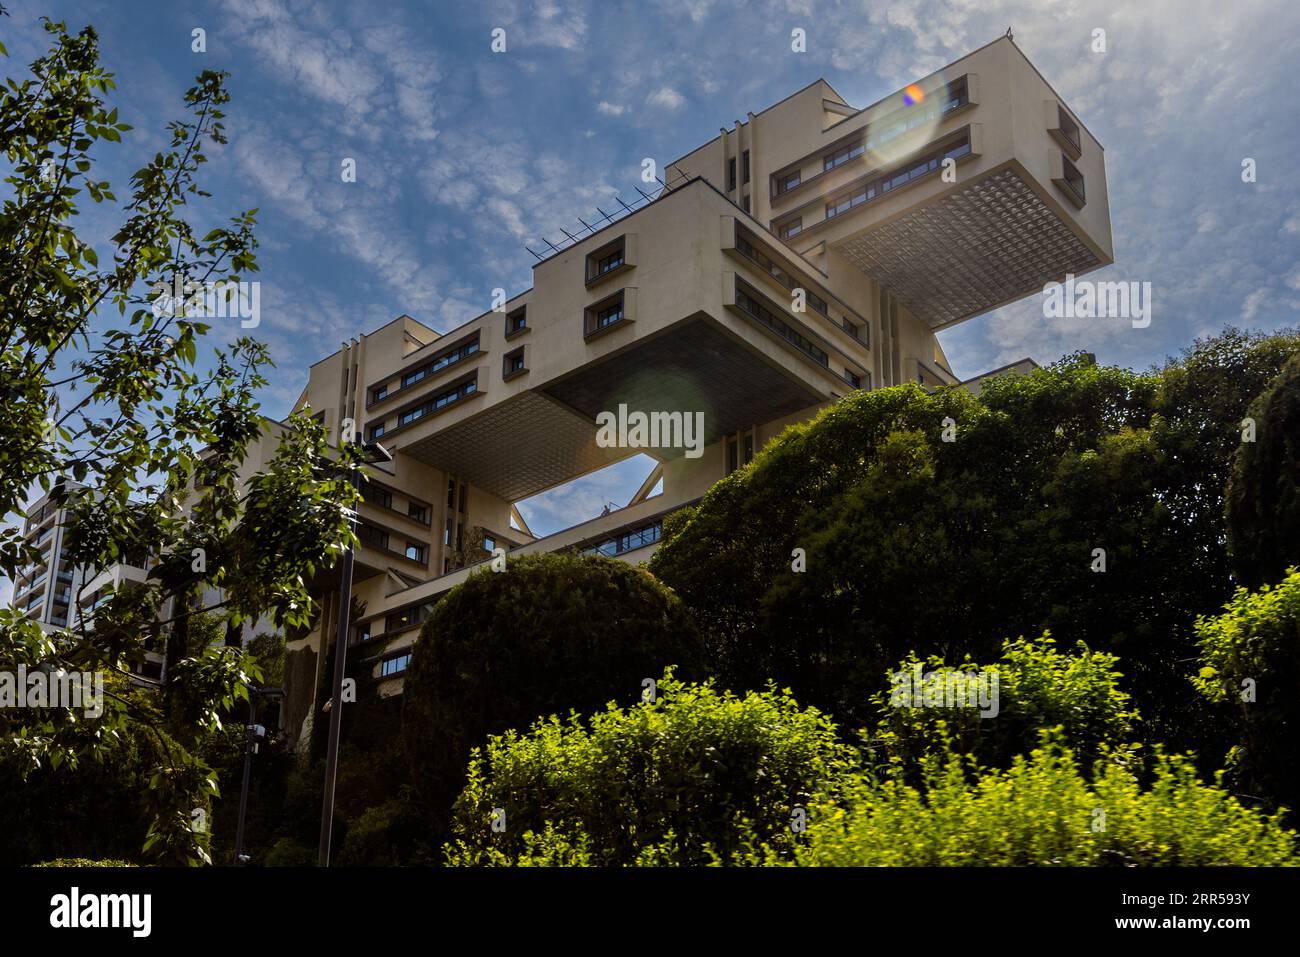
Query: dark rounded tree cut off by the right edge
xmin=1226 ymin=355 xmax=1300 ymax=588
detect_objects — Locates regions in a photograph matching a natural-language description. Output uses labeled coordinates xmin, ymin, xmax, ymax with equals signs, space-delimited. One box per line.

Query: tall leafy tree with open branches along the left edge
xmin=0 ymin=21 xmax=358 ymax=861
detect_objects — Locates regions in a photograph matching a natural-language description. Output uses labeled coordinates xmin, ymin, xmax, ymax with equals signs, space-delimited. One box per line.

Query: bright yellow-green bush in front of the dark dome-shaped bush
xmin=447 ymin=676 xmax=852 ymax=866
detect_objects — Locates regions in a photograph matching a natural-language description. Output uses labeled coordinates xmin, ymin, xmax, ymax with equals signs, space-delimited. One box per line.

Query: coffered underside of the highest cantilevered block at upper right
xmin=835 ymin=168 xmax=1104 ymax=329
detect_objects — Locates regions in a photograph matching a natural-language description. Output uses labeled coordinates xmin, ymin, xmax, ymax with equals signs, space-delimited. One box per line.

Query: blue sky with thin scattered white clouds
xmin=0 ymin=0 xmax=1300 ymax=553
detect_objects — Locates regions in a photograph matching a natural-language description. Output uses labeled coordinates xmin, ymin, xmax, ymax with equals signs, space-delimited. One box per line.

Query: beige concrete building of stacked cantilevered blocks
xmin=271 ymin=38 xmax=1113 ymax=733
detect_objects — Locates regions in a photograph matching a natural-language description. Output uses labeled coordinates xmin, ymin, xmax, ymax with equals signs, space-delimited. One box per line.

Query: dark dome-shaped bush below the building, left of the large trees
xmin=402 ymin=555 xmax=707 ymax=830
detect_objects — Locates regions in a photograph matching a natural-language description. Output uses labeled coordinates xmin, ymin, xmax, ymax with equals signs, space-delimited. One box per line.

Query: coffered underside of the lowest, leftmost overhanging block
xmin=402 ymin=387 xmax=634 ymax=502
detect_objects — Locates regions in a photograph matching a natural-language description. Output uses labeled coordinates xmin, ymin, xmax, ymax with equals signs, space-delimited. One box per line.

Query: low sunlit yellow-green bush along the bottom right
xmin=780 ymin=740 xmax=1300 ymax=867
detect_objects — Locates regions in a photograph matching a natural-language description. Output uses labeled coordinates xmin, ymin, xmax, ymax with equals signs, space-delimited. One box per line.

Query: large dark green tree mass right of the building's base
xmin=650 ymin=340 xmax=1300 ymax=746
